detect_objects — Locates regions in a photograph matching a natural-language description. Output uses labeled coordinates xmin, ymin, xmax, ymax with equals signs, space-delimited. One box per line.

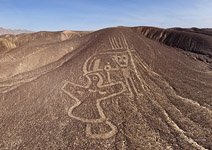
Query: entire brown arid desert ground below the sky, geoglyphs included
xmin=0 ymin=27 xmax=212 ymax=150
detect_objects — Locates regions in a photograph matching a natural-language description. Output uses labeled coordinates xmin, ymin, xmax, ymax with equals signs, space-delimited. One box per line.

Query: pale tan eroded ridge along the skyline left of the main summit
xmin=0 ymin=30 xmax=89 ymax=54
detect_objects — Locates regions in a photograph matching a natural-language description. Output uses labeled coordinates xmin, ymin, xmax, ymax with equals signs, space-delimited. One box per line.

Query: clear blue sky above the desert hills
xmin=0 ymin=0 xmax=212 ymax=31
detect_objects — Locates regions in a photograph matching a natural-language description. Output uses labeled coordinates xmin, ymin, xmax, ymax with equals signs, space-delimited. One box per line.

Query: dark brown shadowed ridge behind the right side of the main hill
xmin=133 ymin=27 xmax=212 ymax=62
